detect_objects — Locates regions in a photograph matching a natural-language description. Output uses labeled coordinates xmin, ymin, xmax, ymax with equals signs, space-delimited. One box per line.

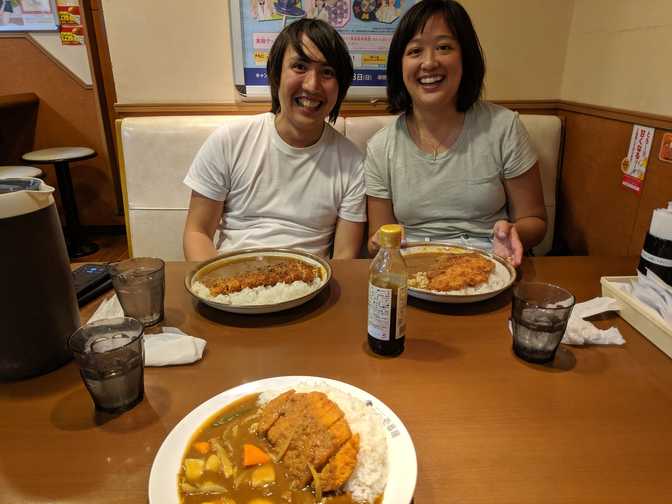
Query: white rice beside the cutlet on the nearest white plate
xmin=259 ymin=382 xmax=387 ymax=504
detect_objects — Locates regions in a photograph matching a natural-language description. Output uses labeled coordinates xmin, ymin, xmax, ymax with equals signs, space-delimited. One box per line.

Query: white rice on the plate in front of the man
xmin=191 ymin=276 xmax=322 ymax=306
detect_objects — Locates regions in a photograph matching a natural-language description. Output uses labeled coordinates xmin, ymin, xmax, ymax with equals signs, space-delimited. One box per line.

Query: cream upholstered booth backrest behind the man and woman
xmin=117 ymin=114 xmax=562 ymax=261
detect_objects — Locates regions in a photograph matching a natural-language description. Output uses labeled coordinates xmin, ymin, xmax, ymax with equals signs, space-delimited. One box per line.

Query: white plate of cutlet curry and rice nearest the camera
xmin=149 ymin=376 xmax=418 ymax=504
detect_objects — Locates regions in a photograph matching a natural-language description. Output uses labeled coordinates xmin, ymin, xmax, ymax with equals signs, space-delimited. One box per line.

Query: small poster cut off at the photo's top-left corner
xmin=0 ymin=0 xmax=58 ymax=32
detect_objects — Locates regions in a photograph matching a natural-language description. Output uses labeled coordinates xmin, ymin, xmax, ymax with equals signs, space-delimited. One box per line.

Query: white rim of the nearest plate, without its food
xmin=149 ymin=376 xmax=418 ymax=504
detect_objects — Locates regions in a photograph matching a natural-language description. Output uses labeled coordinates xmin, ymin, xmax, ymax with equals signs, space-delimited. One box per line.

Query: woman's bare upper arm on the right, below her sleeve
xmin=504 ymin=163 xmax=546 ymax=250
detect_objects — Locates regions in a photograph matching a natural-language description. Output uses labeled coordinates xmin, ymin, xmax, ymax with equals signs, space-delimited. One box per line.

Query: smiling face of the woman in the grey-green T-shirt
xmin=402 ymin=15 xmax=462 ymax=111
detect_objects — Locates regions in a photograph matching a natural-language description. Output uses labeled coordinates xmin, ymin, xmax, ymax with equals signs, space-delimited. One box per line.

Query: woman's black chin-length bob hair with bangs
xmin=387 ymin=0 xmax=485 ymax=113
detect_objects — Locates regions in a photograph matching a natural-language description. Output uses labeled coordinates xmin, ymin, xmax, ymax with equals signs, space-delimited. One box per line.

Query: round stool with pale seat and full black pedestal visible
xmin=22 ymin=147 xmax=98 ymax=258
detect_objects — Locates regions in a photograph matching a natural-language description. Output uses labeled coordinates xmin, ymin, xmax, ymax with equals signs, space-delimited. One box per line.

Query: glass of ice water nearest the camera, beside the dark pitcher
xmin=68 ymin=317 xmax=145 ymax=413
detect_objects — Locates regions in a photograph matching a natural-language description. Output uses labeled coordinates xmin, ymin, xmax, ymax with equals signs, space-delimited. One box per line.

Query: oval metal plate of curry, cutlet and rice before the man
xmin=184 ymin=248 xmax=331 ymax=314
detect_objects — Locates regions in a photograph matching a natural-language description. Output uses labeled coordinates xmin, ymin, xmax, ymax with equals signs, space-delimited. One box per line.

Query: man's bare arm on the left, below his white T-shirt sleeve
xmin=182 ymin=191 xmax=224 ymax=261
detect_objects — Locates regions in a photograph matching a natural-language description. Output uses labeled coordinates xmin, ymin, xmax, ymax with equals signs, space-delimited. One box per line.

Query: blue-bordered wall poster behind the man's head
xmin=230 ymin=0 xmax=416 ymax=100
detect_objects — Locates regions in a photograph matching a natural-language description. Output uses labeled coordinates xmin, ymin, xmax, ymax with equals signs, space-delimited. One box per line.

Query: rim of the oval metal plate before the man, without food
xmin=184 ymin=248 xmax=331 ymax=315
